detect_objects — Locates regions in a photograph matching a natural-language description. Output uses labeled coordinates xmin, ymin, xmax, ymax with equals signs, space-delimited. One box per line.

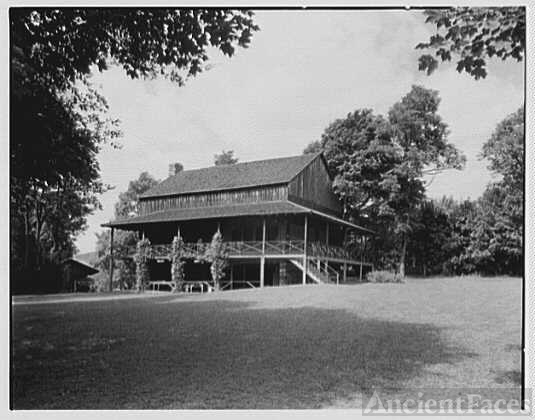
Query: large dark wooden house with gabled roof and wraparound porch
xmin=104 ymin=154 xmax=370 ymax=288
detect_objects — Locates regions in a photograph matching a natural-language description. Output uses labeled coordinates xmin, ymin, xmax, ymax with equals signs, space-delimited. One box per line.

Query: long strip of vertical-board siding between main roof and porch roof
xmin=139 ymin=185 xmax=288 ymax=216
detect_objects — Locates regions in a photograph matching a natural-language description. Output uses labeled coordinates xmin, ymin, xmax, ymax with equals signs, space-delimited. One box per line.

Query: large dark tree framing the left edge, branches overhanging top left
xmin=10 ymin=8 xmax=258 ymax=288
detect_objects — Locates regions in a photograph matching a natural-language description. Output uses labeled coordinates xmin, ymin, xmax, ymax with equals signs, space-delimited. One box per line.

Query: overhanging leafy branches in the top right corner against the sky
xmin=416 ymin=7 xmax=526 ymax=80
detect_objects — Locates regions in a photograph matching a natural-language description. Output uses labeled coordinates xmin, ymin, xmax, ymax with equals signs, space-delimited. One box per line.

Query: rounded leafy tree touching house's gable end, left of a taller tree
xmin=305 ymin=109 xmax=421 ymax=268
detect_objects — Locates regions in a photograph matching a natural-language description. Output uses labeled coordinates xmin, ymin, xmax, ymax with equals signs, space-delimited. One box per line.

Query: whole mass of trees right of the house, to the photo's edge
xmin=305 ymin=86 xmax=524 ymax=276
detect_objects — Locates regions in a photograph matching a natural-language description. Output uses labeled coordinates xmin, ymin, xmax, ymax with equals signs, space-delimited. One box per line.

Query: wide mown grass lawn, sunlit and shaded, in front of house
xmin=12 ymin=277 xmax=521 ymax=409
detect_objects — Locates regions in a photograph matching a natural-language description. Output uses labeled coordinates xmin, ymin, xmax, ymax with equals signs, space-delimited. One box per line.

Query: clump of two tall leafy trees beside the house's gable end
xmin=306 ymin=86 xmax=465 ymax=275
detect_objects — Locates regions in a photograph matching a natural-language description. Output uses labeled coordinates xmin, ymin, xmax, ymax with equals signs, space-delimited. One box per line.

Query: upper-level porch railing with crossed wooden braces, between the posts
xmin=129 ymin=240 xmax=362 ymax=260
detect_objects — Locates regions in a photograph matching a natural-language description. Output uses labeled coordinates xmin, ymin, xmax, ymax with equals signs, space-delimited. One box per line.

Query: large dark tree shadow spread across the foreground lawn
xmin=12 ymin=300 xmax=474 ymax=409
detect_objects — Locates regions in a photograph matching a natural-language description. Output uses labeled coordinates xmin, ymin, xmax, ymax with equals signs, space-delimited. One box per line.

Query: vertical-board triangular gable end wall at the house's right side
xmin=288 ymin=156 xmax=342 ymax=215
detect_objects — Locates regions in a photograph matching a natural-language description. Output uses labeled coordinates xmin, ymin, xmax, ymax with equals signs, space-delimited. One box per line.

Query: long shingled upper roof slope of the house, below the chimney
xmin=140 ymin=153 xmax=319 ymax=198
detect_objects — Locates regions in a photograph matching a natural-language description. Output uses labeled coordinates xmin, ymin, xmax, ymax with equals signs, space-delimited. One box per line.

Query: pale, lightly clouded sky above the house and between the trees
xmin=76 ymin=10 xmax=524 ymax=252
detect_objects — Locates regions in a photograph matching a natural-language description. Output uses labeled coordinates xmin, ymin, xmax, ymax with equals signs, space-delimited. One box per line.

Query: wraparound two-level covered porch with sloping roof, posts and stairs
xmin=105 ymin=203 xmax=373 ymax=289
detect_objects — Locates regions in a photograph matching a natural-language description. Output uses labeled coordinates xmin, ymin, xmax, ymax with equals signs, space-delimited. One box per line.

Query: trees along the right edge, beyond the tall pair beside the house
xmin=412 ymin=109 xmax=524 ymax=275
